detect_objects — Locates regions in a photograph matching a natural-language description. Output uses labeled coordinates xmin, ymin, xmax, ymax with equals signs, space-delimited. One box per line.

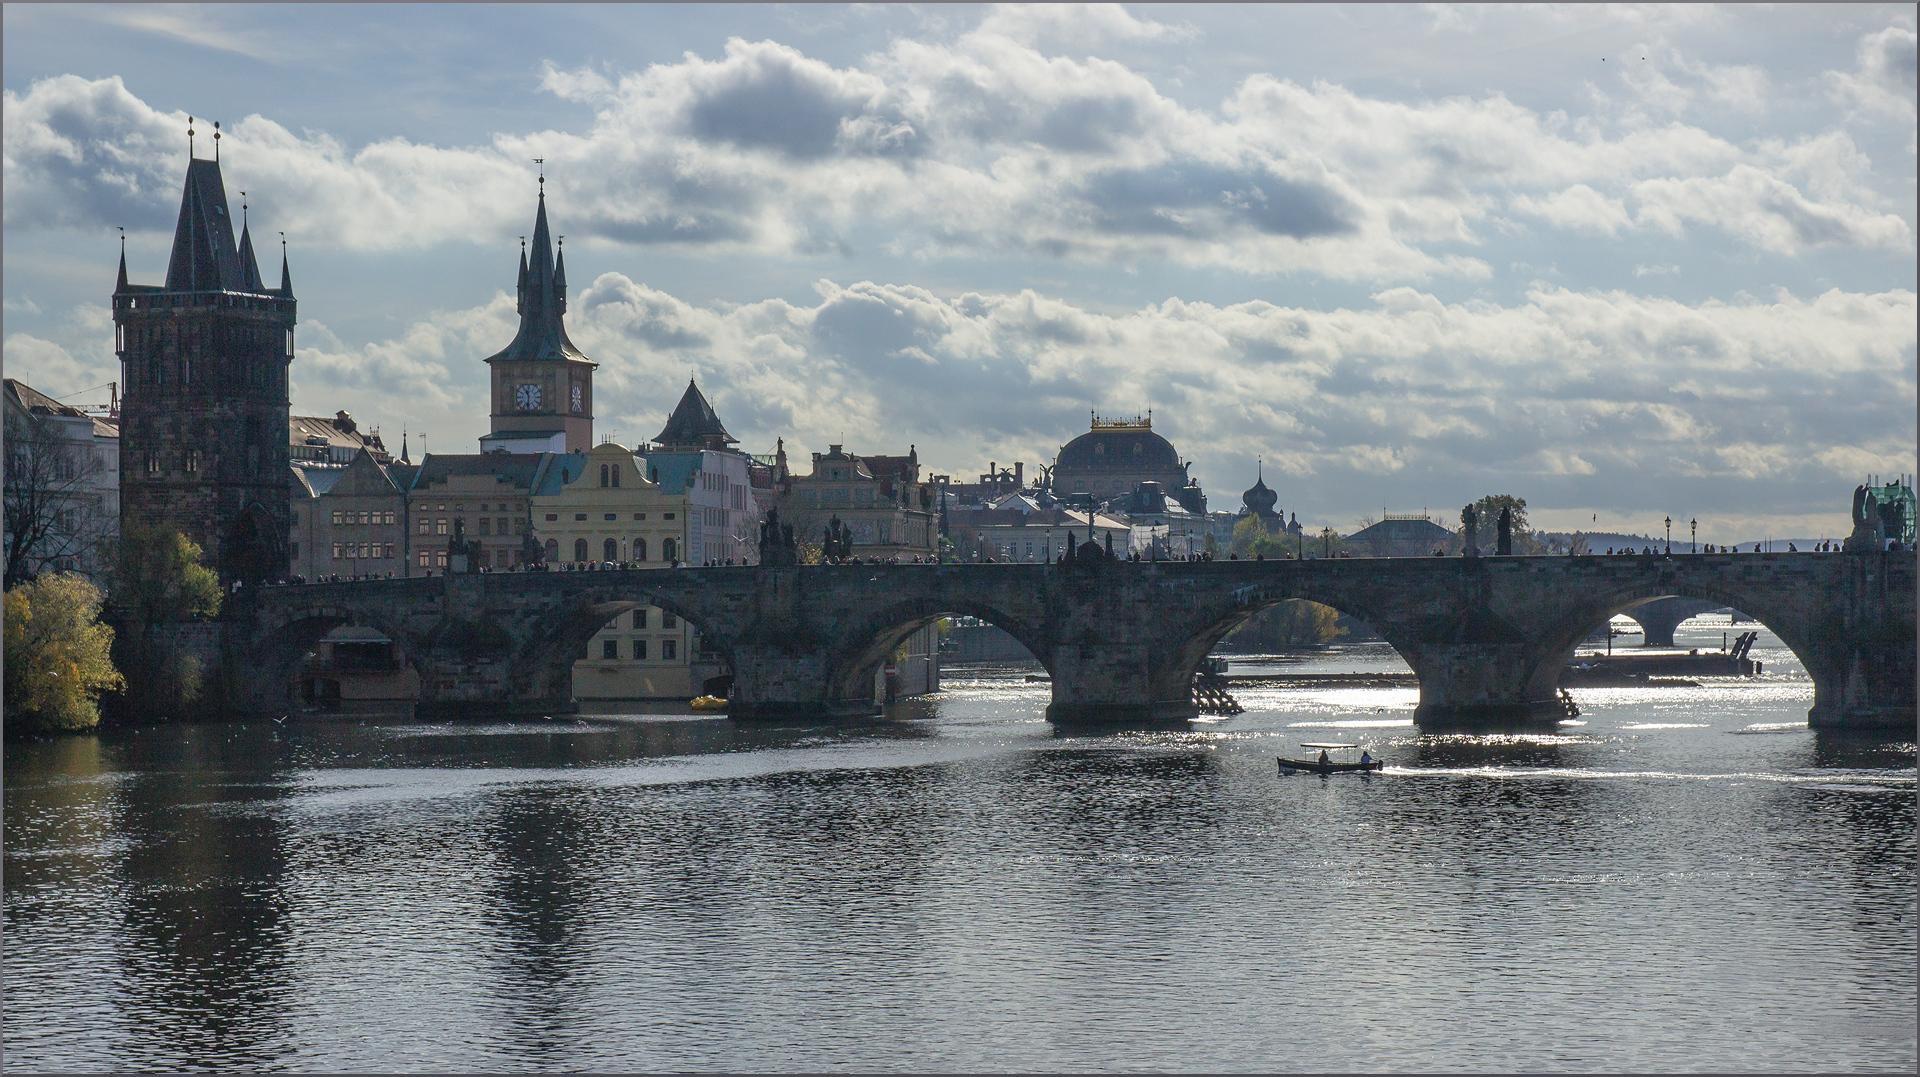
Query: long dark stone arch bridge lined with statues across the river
xmin=227 ymin=553 xmax=1916 ymax=728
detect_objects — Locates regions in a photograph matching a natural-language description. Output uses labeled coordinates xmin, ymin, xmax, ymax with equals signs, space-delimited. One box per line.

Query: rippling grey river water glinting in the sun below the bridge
xmin=4 ymin=618 xmax=1916 ymax=1071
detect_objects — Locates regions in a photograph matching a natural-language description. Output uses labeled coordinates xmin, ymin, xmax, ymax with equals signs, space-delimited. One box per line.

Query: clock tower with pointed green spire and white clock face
xmin=480 ymin=179 xmax=599 ymax=453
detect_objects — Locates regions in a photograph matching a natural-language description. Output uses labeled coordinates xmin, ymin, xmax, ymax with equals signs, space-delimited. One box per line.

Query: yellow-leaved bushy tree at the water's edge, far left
xmin=6 ymin=572 xmax=125 ymax=730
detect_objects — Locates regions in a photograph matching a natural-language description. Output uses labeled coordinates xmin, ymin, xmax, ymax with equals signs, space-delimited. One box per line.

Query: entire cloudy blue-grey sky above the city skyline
xmin=4 ymin=4 xmax=1916 ymax=541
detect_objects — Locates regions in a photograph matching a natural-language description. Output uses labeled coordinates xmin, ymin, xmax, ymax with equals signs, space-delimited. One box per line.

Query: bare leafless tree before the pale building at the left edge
xmin=4 ymin=397 xmax=109 ymax=589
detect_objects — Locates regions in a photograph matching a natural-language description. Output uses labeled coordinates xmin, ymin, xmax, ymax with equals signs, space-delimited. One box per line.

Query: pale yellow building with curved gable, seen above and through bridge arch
xmin=532 ymin=443 xmax=724 ymax=701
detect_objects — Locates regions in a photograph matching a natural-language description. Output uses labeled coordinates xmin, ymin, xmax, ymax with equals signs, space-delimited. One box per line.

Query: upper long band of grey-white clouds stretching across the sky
xmin=6 ymin=8 xmax=1912 ymax=274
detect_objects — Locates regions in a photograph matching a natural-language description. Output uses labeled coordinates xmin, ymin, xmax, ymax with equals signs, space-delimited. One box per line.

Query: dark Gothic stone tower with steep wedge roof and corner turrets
xmin=113 ymin=131 xmax=296 ymax=584
